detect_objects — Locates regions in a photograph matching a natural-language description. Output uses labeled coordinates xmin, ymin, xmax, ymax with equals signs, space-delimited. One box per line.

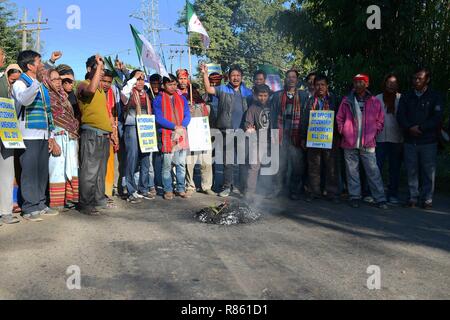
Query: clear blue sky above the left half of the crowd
xmin=10 ymin=0 xmax=197 ymax=79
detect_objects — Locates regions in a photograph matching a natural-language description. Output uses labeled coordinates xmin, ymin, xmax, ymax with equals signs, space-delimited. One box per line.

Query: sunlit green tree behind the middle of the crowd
xmin=178 ymin=0 xmax=312 ymax=79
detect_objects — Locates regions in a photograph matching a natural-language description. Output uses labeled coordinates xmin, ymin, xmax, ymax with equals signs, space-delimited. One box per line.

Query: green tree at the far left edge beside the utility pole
xmin=0 ymin=0 xmax=21 ymax=65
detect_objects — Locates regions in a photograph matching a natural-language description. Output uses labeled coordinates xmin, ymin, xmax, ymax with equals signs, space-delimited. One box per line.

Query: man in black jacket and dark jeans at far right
xmin=397 ymin=68 xmax=444 ymax=209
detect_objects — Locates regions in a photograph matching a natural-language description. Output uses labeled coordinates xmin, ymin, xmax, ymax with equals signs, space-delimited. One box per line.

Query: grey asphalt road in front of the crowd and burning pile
xmin=0 ymin=190 xmax=450 ymax=299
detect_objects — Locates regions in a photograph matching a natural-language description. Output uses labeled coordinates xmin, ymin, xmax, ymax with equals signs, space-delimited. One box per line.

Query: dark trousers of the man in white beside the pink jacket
xmin=376 ymin=142 xmax=403 ymax=198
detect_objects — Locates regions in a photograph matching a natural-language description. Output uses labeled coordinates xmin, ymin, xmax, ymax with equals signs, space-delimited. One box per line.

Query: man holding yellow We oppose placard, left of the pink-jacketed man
xmin=301 ymin=75 xmax=339 ymax=202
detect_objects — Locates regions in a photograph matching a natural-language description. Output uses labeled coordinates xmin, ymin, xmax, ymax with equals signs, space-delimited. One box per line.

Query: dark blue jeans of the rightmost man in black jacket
xmin=405 ymin=143 xmax=437 ymax=202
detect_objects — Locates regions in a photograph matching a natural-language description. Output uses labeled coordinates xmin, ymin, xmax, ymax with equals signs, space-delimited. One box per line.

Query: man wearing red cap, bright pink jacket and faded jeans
xmin=336 ymin=74 xmax=387 ymax=209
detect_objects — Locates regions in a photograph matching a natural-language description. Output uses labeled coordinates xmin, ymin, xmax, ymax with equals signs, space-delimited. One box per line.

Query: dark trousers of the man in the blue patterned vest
xmin=19 ymin=139 xmax=49 ymax=214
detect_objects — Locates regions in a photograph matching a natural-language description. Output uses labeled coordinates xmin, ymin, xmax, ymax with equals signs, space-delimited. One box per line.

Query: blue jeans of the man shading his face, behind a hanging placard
xmin=124 ymin=126 xmax=154 ymax=195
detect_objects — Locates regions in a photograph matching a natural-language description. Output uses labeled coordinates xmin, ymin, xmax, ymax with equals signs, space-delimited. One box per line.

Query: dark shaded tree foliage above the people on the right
xmin=275 ymin=0 xmax=450 ymax=98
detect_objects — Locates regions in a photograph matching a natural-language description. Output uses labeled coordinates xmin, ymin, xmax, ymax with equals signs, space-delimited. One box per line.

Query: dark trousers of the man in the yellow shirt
xmin=79 ymin=130 xmax=110 ymax=209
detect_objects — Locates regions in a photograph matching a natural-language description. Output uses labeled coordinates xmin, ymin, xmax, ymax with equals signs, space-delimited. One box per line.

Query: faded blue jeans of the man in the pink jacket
xmin=344 ymin=149 xmax=386 ymax=203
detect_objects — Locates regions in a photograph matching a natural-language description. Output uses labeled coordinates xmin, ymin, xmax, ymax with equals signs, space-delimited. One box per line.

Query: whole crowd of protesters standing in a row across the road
xmin=0 ymin=49 xmax=444 ymax=228
